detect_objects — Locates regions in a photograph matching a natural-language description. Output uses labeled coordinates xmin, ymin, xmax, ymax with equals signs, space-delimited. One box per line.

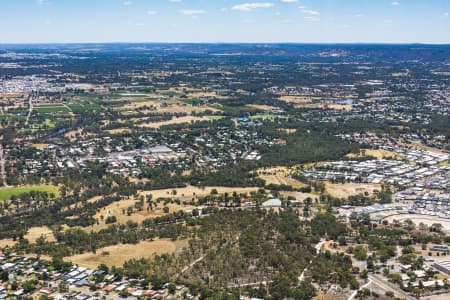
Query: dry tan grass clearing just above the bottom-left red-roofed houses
xmin=65 ymin=240 xmax=187 ymax=269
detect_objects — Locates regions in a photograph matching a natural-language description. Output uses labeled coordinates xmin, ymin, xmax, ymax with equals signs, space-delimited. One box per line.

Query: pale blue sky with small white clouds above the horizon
xmin=0 ymin=0 xmax=450 ymax=44
